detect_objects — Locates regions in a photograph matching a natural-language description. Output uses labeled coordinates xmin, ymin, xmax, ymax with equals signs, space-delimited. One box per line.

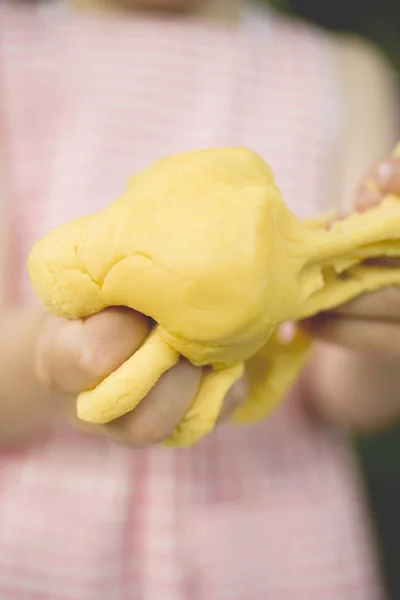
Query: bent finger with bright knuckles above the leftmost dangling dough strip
xmin=37 ymin=308 xmax=149 ymax=394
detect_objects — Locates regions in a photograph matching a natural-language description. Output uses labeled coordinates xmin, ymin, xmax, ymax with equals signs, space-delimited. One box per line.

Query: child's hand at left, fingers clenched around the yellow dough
xmin=36 ymin=308 xmax=244 ymax=446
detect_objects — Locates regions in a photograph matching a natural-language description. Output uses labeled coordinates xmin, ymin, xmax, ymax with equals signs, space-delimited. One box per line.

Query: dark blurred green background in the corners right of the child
xmin=269 ymin=0 xmax=400 ymax=600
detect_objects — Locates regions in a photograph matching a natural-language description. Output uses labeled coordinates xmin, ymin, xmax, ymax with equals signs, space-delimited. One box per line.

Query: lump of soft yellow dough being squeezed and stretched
xmin=28 ymin=148 xmax=400 ymax=446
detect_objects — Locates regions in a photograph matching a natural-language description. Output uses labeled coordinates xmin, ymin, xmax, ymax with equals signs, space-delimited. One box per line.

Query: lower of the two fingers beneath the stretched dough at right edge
xmin=306 ymin=316 xmax=400 ymax=360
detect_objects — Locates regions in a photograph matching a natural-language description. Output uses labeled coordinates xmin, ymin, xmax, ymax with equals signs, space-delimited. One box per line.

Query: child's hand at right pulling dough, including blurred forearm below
xmin=304 ymin=158 xmax=400 ymax=431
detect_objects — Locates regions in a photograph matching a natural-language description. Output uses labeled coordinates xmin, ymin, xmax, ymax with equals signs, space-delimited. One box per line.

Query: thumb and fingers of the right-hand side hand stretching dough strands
xmin=306 ymin=158 xmax=400 ymax=360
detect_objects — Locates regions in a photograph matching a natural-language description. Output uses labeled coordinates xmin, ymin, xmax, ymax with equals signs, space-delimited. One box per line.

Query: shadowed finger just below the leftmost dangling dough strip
xmin=102 ymin=361 xmax=202 ymax=447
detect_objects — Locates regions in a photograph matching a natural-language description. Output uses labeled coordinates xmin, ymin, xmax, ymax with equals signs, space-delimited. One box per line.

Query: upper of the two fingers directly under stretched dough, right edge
xmin=324 ymin=286 xmax=400 ymax=323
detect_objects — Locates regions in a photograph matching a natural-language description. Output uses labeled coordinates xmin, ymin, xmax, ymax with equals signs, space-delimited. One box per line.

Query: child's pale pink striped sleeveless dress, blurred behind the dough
xmin=0 ymin=2 xmax=382 ymax=600
